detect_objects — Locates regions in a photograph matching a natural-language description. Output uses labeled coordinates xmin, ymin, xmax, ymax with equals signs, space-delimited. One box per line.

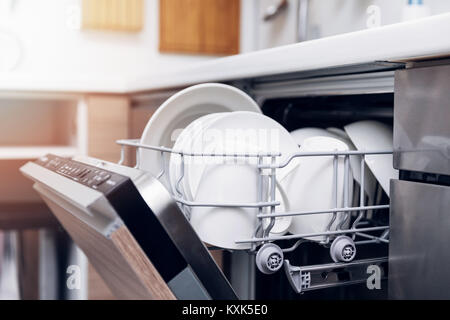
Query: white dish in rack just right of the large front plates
xmin=280 ymin=136 xmax=353 ymax=241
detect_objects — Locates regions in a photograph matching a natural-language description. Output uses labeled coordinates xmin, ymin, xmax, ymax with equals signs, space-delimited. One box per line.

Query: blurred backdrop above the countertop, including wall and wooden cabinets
xmin=0 ymin=0 xmax=450 ymax=79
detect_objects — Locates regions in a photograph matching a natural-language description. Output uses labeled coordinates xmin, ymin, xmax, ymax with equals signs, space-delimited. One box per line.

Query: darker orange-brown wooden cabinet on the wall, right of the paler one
xmin=159 ymin=0 xmax=240 ymax=55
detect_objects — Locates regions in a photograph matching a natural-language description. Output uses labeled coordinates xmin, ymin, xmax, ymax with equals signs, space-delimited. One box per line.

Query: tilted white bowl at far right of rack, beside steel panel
xmin=344 ymin=121 xmax=398 ymax=196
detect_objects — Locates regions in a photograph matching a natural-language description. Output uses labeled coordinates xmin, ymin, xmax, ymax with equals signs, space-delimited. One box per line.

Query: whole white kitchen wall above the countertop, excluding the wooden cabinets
xmin=0 ymin=0 xmax=450 ymax=81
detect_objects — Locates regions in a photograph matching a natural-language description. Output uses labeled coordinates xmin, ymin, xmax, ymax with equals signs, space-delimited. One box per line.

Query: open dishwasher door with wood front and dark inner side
xmin=20 ymin=155 xmax=237 ymax=300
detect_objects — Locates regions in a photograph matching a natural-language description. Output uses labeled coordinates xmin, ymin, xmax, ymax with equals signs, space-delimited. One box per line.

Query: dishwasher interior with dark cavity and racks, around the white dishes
xmin=125 ymin=66 xmax=398 ymax=300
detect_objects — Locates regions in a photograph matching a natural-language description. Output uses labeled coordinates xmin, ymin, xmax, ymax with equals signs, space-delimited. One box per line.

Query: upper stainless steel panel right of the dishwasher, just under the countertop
xmin=394 ymin=65 xmax=450 ymax=175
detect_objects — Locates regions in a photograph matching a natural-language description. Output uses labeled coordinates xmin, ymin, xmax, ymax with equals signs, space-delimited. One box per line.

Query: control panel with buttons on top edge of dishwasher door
xmin=36 ymin=154 xmax=129 ymax=193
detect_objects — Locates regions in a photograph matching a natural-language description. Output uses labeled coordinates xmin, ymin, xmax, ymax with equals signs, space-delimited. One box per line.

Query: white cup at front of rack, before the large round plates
xmin=190 ymin=142 xmax=292 ymax=250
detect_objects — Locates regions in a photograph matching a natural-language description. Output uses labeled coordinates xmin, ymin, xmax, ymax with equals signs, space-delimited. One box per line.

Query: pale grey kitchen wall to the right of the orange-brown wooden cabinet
xmin=248 ymin=0 xmax=450 ymax=51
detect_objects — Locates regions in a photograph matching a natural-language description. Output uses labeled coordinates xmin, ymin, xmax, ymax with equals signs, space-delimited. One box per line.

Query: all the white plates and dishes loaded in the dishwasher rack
xmin=140 ymin=84 xmax=398 ymax=250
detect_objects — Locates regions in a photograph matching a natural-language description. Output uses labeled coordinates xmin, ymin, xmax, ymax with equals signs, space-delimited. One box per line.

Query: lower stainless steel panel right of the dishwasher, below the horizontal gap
xmin=389 ymin=180 xmax=450 ymax=299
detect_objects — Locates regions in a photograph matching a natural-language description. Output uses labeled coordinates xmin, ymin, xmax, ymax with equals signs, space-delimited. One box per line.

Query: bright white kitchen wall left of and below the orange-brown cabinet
xmin=0 ymin=0 xmax=225 ymax=79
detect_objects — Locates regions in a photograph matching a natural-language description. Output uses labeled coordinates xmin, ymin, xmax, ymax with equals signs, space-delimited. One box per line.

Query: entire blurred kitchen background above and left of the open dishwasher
xmin=0 ymin=0 xmax=450 ymax=299
